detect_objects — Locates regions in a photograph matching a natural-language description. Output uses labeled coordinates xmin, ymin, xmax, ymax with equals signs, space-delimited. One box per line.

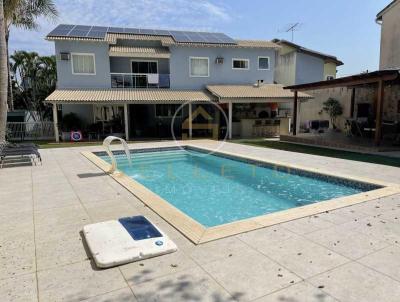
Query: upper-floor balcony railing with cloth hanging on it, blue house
xmin=110 ymin=73 xmax=170 ymax=88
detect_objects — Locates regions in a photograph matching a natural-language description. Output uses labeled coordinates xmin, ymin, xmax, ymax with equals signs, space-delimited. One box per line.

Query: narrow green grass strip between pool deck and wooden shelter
xmin=232 ymin=139 xmax=400 ymax=167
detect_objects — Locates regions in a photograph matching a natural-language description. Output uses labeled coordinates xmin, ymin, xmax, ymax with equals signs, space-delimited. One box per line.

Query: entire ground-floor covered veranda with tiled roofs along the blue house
xmin=46 ymin=83 xmax=311 ymax=142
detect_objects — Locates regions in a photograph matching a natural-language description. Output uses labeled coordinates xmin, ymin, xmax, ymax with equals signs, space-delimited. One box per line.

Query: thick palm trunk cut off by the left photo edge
xmin=0 ymin=0 xmax=8 ymax=142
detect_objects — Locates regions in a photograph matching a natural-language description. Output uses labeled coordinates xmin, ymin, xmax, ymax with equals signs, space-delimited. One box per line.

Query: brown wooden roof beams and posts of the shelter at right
xmin=284 ymin=69 xmax=400 ymax=145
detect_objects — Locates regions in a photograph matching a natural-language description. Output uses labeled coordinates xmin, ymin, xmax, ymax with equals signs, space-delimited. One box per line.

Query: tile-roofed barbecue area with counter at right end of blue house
xmin=207 ymin=83 xmax=312 ymax=139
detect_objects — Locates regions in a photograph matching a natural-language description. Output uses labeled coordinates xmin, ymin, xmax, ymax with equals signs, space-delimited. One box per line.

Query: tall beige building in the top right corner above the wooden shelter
xmin=376 ymin=0 xmax=400 ymax=70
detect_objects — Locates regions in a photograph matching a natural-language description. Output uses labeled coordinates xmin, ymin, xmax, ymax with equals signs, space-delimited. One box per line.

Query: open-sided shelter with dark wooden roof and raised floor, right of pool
xmin=281 ymin=70 xmax=400 ymax=151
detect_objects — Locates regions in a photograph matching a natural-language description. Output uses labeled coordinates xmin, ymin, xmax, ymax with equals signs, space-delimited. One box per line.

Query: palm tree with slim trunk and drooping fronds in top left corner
xmin=3 ymin=0 xmax=58 ymax=110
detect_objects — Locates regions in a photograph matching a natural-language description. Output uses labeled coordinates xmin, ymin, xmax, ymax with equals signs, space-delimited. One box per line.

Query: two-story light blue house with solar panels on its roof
xmin=47 ymin=24 xmax=308 ymax=140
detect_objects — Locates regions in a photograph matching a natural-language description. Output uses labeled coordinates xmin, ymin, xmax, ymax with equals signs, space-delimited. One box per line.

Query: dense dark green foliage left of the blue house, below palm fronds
xmin=10 ymin=51 xmax=57 ymax=120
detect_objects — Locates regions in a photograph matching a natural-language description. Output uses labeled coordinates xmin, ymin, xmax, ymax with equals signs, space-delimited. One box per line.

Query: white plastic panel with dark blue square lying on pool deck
xmin=83 ymin=216 xmax=177 ymax=268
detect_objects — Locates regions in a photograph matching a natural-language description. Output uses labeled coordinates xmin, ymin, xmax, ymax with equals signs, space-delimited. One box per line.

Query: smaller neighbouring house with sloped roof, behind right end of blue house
xmin=272 ymin=39 xmax=343 ymax=85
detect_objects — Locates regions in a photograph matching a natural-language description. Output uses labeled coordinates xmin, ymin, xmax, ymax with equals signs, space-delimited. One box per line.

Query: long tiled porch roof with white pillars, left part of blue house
xmin=46 ymin=89 xmax=216 ymax=142
